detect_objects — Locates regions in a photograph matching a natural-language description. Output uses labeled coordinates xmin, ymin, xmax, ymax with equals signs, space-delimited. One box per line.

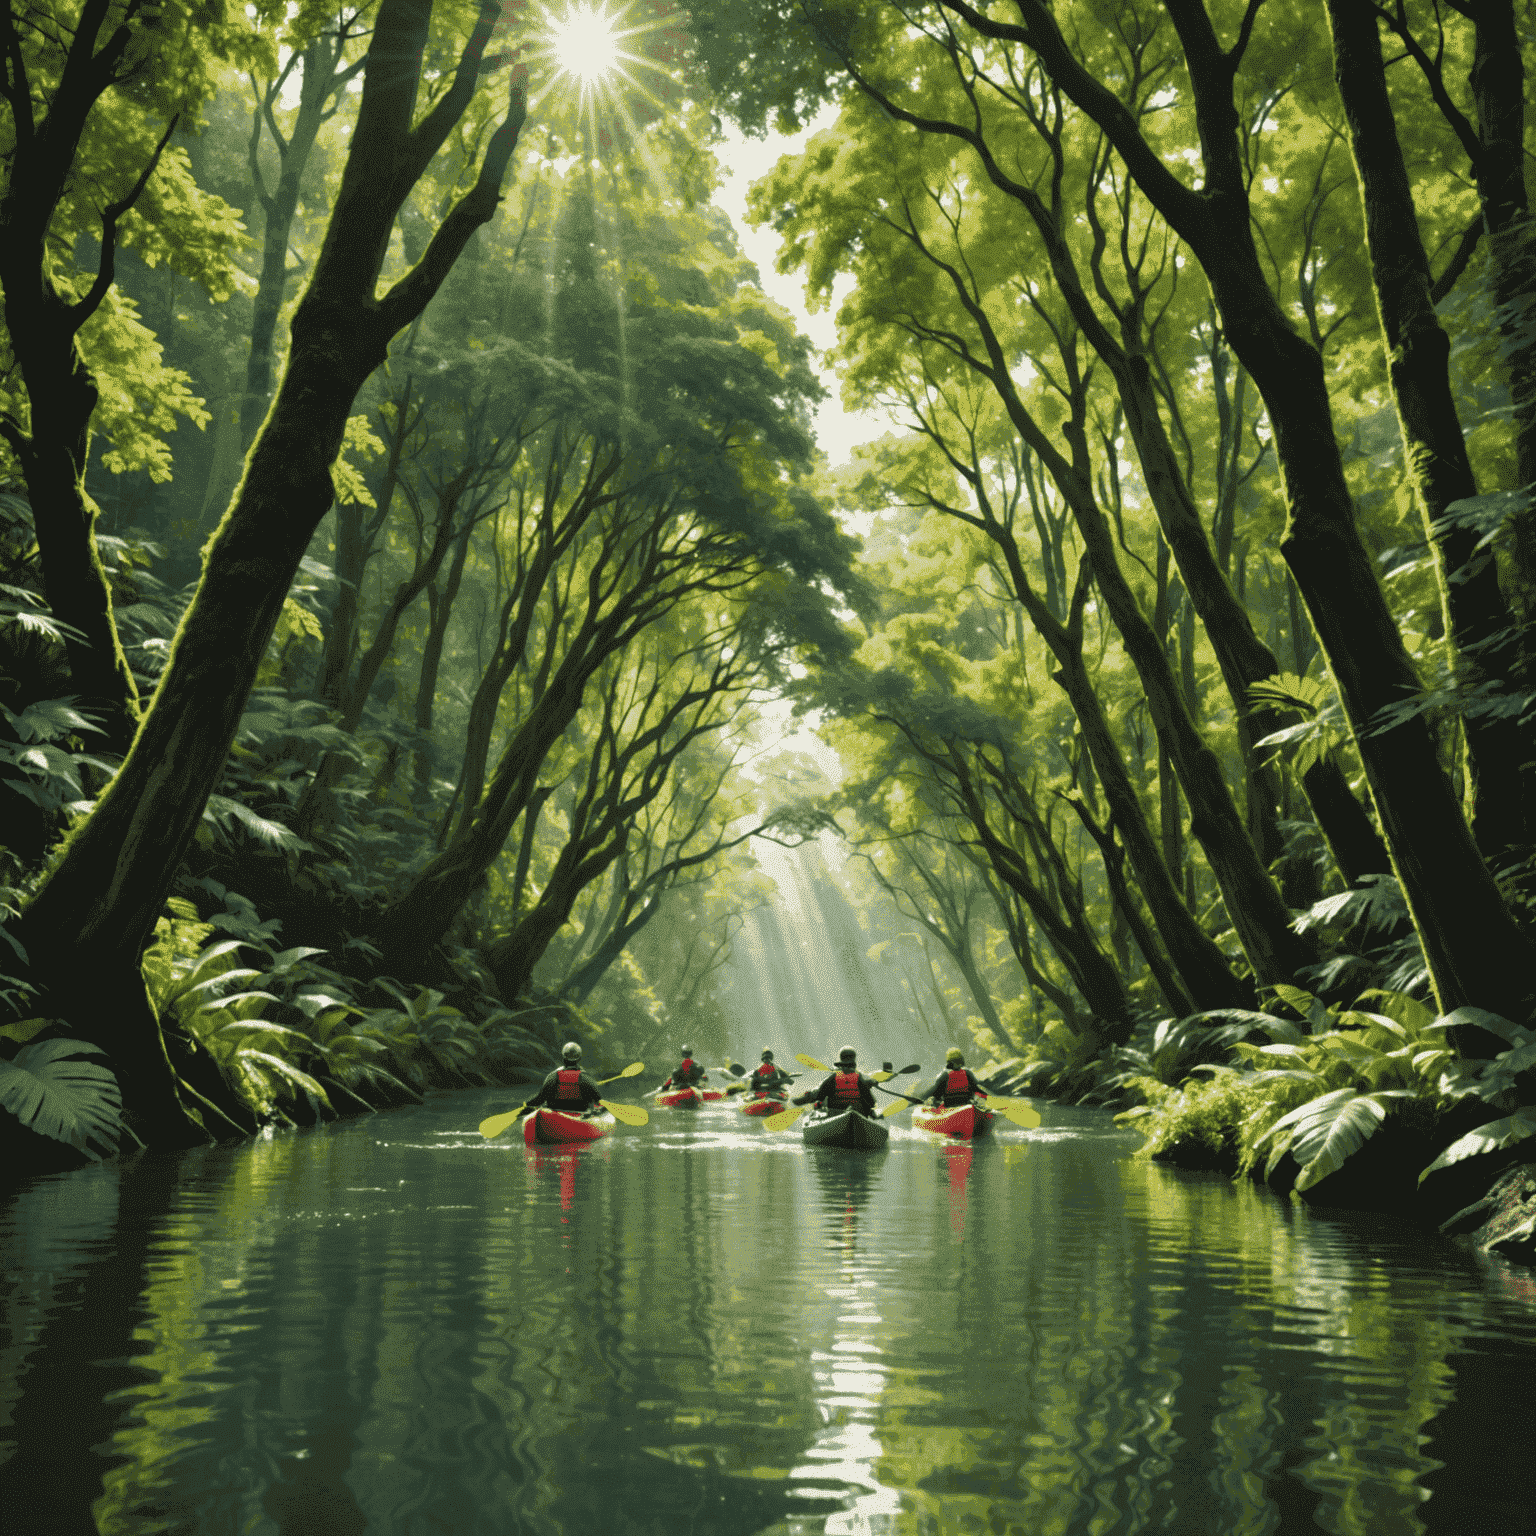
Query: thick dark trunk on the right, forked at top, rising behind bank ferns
xmin=995 ymin=0 xmax=1536 ymax=1018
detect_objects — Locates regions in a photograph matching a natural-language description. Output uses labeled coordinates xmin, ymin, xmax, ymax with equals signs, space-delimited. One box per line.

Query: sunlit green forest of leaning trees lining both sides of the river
xmin=0 ymin=0 xmax=1536 ymax=1173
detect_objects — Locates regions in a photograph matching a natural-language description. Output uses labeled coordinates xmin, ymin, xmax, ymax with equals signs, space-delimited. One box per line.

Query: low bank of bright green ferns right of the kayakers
xmin=983 ymin=989 xmax=1536 ymax=1266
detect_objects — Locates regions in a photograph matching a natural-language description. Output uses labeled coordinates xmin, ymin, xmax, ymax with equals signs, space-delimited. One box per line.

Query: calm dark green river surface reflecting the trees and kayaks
xmin=0 ymin=1092 xmax=1536 ymax=1536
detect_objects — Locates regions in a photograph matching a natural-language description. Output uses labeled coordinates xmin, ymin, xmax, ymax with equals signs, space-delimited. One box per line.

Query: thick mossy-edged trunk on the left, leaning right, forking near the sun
xmin=22 ymin=0 xmax=525 ymax=1130
